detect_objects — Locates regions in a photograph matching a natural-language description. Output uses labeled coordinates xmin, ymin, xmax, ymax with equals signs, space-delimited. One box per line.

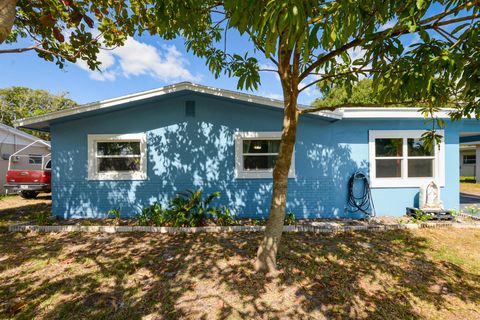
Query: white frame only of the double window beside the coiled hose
xmin=368 ymin=130 xmax=445 ymax=188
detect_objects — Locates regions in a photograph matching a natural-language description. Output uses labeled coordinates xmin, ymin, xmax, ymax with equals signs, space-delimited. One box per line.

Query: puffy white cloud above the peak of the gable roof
xmin=77 ymin=38 xmax=199 ymax=82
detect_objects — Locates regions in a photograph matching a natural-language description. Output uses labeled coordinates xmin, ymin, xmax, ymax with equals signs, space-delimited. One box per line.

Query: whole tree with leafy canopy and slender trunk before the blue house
xmin=128 ymin=0 xmax=480 ymax=271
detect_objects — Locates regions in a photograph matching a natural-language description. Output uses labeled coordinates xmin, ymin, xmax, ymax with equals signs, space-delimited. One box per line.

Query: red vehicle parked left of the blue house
xmin=4 ymin=140 xmax=52 ymax=199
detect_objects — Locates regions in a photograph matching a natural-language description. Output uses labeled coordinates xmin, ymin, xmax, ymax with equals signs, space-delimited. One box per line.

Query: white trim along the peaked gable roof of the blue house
xmin=15 ymin=82 xmax=342 ymax=127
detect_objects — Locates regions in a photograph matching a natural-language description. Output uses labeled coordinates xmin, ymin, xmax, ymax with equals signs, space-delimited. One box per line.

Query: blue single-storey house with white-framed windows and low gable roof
xmin=18 ymin=83 xmax=480 ymax=218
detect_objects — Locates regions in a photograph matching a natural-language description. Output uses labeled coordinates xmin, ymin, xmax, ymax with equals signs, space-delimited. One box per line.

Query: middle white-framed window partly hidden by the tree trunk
xmin=235 ymin=132 xmax=295 ymax=179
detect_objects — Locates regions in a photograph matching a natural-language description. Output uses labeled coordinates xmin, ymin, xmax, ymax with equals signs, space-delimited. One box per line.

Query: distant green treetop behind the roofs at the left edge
xmin=0 ymin=87 xmax=77 ymax=139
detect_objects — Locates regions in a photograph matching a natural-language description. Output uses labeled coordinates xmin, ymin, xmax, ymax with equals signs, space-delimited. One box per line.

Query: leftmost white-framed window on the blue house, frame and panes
xmin=88 ymin=133 xmax=147 ymax=180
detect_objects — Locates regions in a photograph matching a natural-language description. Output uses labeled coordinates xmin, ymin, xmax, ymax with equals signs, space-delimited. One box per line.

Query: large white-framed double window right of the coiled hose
xmin=369 ymin=130 xmax=445 ymax=188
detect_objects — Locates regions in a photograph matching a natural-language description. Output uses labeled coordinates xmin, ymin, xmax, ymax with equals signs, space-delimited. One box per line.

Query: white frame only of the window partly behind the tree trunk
xmin=235 ymin=132 xmax=295 ymax=179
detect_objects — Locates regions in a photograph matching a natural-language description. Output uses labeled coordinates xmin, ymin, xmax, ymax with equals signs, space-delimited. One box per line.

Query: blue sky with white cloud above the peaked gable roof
xmin=0 ymin=30 xmax=319 ymax=104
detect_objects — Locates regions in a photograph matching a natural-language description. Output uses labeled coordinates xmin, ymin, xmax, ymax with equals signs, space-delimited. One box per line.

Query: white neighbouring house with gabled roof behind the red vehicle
xmin=0 ymin=123 xmax=45 ymax=194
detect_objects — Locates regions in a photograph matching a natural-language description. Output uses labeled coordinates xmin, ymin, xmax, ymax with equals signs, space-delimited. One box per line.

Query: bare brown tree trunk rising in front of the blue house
xmin=255 ymin=89 xmax=298 ymax=273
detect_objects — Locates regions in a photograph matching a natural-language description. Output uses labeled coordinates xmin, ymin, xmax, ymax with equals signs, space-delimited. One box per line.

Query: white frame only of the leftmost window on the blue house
xmin=88 ymin=133 xmax=147 ymax=180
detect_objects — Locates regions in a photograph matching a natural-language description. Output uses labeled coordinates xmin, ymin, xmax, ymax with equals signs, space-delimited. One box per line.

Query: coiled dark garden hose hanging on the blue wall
xmin=347 ymin=171 xmax=375 ymax=219
